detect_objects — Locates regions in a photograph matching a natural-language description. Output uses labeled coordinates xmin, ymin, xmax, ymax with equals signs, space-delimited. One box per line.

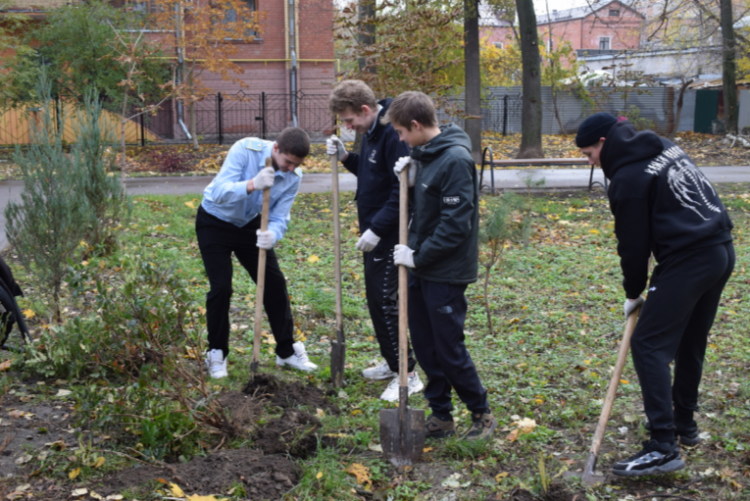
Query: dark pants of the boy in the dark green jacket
xmin=409 ymin=275 xmax=489 ymax=418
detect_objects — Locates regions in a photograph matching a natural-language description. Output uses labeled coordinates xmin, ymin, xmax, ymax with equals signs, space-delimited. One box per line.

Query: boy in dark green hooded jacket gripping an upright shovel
xmin=384 ymin=92 xmax=497 ymax=440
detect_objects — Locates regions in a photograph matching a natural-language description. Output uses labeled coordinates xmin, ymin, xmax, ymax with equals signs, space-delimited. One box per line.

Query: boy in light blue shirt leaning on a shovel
xmin=195 ymin=127 xmax=318 ymax=378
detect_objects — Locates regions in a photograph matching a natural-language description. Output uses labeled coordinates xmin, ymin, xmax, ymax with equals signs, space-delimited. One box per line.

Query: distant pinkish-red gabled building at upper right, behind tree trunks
xmin=480 ymin=0 xmax=644 ymax=54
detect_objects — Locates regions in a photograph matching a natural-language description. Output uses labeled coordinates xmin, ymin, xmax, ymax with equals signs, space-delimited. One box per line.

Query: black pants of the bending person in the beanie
xmin=631 ymin=242 xmax=735 ymax=442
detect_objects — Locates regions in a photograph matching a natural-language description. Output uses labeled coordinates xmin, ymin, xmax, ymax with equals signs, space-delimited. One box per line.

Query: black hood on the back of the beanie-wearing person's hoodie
xmin=599 ymin=120 xmax=664 ymax=179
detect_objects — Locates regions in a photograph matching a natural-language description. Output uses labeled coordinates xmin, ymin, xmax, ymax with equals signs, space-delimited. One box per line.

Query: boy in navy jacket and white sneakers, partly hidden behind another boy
xmin=326 ymin=80 xmax=424 ymax=402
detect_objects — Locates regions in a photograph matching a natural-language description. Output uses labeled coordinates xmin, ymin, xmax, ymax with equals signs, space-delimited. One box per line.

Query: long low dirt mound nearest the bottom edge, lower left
xmin=96 ymin=449 xmax=299 ymax=499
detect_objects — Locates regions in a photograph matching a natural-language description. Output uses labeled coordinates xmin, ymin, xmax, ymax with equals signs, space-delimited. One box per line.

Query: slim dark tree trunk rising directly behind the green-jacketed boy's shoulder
xmin=464 ymin=0 xmax=482 ymax=164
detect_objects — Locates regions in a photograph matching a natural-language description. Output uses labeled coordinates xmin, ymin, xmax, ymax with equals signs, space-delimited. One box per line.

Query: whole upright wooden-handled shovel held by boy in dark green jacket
xmin=380 ymin=169 xmax=425 ymax=468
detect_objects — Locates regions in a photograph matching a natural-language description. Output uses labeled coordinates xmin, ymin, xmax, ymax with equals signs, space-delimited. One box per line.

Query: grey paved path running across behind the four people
xmin=0 ymin=166 xmax=750 ymax=250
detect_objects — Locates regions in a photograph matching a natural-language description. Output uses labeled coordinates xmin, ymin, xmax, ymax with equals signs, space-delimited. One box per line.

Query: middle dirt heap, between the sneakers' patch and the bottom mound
xmin=255 ymin=409 xmax=321 ymax=459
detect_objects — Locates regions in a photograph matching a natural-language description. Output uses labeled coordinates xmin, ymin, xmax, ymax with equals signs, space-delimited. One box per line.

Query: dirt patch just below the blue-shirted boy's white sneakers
xmin=242 ymin=374 xmax=341 ymax=415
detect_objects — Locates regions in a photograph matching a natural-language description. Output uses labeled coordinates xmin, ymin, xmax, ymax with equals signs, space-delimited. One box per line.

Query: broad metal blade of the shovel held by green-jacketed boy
xmin=380 ymin=398 xmax=425 ymax=468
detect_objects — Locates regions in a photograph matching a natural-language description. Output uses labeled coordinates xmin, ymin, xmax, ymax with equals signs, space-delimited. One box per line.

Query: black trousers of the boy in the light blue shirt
xmin=195 ymin=206 xmax=294 ymax=358
